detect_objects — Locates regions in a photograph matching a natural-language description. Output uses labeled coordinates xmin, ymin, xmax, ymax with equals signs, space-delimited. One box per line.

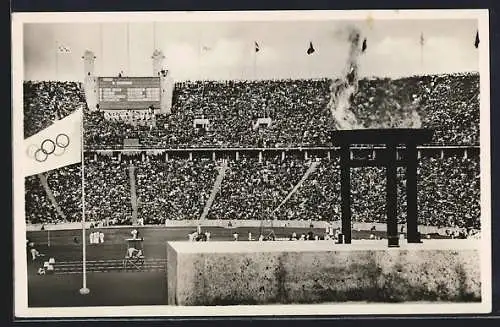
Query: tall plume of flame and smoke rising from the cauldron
xmin=328 ymin=27 xmax=363 ymax=129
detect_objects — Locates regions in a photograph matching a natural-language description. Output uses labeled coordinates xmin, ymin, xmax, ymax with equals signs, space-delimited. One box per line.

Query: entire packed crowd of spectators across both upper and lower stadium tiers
xmin=24 ymin=74 xmax=480 ymax=228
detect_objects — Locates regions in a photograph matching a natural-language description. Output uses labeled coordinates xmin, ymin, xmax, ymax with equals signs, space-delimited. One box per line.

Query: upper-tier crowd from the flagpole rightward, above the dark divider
xmin=77 ymin=74 xmax=479 ymax=149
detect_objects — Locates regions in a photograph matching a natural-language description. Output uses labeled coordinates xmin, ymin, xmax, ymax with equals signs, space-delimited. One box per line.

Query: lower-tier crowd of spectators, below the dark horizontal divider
xmin=26 ymin=155 xmax=480 ymax=228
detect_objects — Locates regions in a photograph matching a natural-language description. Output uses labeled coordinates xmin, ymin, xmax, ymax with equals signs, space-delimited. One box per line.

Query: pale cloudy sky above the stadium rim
xmin=23 ymin=19 xmax=479 ymax=81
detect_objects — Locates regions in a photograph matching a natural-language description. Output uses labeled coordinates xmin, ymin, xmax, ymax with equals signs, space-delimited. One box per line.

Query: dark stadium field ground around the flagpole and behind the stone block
xmin=23 ymin=227 xmax=446 ymax=307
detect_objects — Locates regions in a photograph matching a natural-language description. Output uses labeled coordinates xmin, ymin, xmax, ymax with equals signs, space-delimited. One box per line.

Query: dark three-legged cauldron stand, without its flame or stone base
xmin=331 ymin=128 xmax=434 ymax=247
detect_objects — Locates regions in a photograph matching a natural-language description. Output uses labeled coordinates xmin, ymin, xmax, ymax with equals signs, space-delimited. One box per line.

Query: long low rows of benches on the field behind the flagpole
xmin=50 ymin=259 xmax=167 ymax=274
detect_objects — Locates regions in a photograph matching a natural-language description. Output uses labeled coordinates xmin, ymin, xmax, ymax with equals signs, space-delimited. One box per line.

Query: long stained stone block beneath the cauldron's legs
xmin=167 ymin=240 xmax=481 ymax=306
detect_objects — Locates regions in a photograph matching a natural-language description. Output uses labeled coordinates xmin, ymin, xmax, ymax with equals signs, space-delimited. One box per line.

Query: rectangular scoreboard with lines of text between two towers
xmin=97 ymin=77 xmax=160 ymax=110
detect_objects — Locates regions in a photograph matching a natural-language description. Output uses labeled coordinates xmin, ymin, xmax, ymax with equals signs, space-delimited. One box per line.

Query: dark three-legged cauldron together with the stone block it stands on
xmin=166 ymin=129 xmax=482 ymax=306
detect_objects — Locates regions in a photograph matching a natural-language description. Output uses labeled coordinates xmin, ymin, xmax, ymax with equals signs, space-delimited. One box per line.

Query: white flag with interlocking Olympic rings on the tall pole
xmin=22 ymin=109 xmax=83 ymax=176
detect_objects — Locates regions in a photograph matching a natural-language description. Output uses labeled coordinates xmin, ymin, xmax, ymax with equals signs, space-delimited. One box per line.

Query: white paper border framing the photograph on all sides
xmin=12 ymin=9 xmax=492 ymax=318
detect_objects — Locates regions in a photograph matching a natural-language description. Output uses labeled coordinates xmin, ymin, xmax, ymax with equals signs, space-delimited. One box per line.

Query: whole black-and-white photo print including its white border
xmin=12 ymin=10 xmax=492 ymax=317
